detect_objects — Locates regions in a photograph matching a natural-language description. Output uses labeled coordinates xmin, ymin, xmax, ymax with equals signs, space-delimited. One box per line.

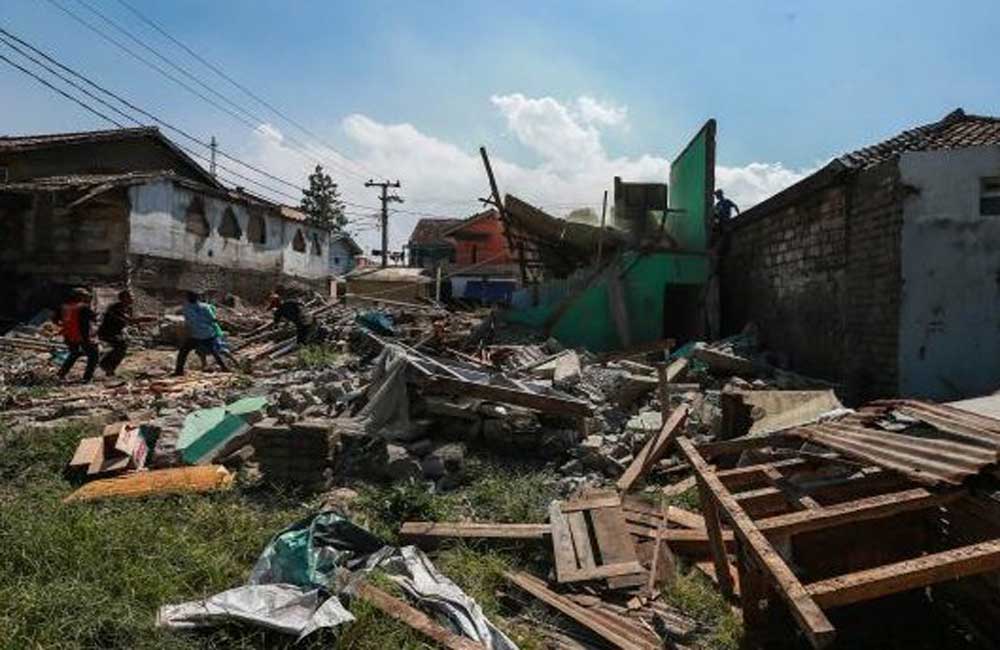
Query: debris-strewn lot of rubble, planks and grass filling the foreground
xmin=0 ymin=298 xmax=1000 ymax=649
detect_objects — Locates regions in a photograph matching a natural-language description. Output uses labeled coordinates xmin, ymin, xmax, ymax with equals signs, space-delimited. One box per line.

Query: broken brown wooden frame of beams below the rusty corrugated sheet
xmin=680 ymin=437 xmax=1000 ymax=648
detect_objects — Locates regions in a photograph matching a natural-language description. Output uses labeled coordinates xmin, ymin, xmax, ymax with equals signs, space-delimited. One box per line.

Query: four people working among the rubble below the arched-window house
xmin=53 ymin=289 xmax=325 ymax=383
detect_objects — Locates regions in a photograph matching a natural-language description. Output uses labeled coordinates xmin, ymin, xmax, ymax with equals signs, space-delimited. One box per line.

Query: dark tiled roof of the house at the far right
xmin=837 ymin=108 xmax=1000 ymax=169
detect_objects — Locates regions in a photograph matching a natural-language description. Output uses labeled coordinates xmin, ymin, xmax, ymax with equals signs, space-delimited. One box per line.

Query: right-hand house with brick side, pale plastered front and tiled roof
xmin=721 ymin=109 xmax=1000 ymax=400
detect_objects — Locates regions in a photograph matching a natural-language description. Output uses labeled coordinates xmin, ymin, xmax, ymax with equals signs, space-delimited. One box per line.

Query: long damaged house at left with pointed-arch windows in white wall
xmin=0 ymin=128 xmax=330 ymax=315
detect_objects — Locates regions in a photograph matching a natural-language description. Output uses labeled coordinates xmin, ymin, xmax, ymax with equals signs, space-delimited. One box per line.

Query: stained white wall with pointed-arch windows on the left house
xmin=129 ymin=180 xmax=329 ymax=278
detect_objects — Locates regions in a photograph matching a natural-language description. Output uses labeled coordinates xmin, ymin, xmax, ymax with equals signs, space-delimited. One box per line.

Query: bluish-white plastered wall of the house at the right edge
xmin=900 ymin=146 xmax=1000 ymax=399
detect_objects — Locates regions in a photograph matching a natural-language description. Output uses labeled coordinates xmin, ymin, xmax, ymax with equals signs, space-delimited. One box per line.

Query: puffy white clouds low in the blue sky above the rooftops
xmin=238 ymin=93 xmax=812 ymax=250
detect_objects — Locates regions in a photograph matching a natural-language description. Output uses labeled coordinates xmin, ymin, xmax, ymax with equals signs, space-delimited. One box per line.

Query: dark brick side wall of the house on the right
xmin=720 ymin=163 xmax=902 ymax=401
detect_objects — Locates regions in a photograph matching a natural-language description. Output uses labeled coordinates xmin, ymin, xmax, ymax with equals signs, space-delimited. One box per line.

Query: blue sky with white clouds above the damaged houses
xmin=0 ymin=0 xmax=1000 ymax=249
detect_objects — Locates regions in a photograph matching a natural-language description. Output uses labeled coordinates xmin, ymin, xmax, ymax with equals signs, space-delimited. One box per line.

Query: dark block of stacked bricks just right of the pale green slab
xmin=252 ymin=419 xmax=336 ymax=491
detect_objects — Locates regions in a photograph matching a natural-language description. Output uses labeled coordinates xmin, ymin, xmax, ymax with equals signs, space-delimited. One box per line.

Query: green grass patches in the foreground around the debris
xmin=0 ymin=418 xmax=738 ymax=650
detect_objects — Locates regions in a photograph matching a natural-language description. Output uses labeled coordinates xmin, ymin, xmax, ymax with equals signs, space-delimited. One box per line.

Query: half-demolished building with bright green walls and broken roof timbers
xmin=503 ymin=120 xmax=718 ymax=352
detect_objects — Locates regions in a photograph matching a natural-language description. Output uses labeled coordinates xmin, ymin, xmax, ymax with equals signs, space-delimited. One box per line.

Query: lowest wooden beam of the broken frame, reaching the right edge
xmin=807 ymin=539 xmax=1000 ymax=607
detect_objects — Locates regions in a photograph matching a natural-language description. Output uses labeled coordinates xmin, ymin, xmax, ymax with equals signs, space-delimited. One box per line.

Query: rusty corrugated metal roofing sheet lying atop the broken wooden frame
xmin=789 ymin=400 xmax=1000 ymax=486
